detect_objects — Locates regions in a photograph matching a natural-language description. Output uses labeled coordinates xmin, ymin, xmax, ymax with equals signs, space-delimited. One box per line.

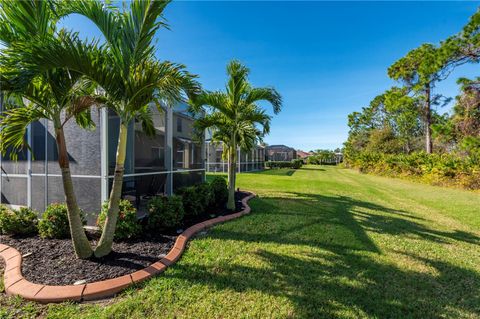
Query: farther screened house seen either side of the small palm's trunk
xmin=205 ymin=142 xmax=265 ymax=173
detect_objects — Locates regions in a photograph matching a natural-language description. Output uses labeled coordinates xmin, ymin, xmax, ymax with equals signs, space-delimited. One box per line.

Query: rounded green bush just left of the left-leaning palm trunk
xmin=38 ymin=203 xmax=81 ymax=239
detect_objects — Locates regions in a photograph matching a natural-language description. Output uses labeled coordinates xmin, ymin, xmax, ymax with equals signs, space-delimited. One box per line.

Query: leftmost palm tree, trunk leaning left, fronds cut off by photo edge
xmin=0 ymin=1 xmax=96 ymax=258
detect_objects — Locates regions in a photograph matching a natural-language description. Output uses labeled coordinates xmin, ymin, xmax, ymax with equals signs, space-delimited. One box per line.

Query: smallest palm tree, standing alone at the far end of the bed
xmin=191 ymin=60 xmax=282 ymax=210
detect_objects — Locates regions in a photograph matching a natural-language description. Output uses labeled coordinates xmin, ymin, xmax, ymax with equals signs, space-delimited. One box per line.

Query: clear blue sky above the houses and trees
xmin=65 ymin=1 xmax=479 ymax=150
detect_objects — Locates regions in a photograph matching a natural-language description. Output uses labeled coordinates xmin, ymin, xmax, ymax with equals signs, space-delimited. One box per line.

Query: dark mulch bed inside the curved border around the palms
xmin=0 ymin=192 xmax=248 ymax=285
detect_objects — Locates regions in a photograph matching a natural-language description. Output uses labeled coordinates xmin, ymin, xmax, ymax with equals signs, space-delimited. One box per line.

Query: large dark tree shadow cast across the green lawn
xmin=173 ymin=193 xmax=480 ymax=318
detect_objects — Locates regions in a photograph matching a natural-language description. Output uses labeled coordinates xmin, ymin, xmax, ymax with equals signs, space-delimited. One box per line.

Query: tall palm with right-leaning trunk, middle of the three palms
xmin=11 ymin=0 xmax=199 ymax=257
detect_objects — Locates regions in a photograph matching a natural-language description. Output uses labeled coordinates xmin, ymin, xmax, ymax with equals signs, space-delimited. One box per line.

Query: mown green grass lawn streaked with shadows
xmin=0 ymin=166 xmax=480 ymax=318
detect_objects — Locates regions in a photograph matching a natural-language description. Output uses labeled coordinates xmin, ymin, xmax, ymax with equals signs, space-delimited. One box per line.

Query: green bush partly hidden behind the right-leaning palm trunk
xmin=97 ymin=199 xmax=142 ymax=240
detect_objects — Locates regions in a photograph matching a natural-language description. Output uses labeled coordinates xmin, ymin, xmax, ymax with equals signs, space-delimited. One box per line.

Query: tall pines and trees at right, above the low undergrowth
xmin=344 ymin=11 xmax=480 ymax=190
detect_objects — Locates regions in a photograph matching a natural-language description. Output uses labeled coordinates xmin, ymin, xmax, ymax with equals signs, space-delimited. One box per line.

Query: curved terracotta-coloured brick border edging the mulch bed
xmin=0 ymin=193 xmax=255 ymax=303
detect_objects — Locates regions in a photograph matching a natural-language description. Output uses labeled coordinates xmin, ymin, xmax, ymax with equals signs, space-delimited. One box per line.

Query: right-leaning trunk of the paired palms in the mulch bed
xmin=95 ymin=123 xmax=128 ymax=257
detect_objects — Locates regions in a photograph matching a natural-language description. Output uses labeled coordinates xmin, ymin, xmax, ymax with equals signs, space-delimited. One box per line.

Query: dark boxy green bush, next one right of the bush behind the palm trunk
xmin=146 ymin=195 xmax=185 ymax=233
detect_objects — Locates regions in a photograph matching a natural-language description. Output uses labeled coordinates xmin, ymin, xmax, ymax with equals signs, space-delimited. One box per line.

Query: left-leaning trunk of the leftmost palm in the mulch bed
xmin=55 ymin=127 xmax=93 ymax=259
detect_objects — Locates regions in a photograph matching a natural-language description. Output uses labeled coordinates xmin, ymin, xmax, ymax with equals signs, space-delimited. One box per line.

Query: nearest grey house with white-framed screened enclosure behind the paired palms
xmin=0 ymin=105 xmax=205 ymax=222
